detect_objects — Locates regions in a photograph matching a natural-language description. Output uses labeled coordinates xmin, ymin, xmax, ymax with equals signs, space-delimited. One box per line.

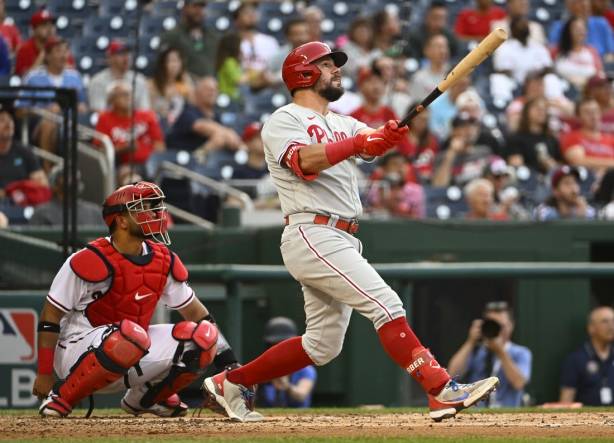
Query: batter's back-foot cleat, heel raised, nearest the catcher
xmin=201 ymin=371 xmax=264 ymax=422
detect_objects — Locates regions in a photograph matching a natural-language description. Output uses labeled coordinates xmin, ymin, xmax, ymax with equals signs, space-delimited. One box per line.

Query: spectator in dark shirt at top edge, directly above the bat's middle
xmin=404 ymin=0 xmax=462 ymax=60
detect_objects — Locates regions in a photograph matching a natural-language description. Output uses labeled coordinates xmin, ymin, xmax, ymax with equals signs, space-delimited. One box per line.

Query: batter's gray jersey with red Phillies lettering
xmin=262 ymin=103 xmax=367 ymax=219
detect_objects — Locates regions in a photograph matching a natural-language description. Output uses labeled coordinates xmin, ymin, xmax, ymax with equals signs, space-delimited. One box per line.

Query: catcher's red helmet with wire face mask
xmin=102 ymin=181 xmax=171 ymax=245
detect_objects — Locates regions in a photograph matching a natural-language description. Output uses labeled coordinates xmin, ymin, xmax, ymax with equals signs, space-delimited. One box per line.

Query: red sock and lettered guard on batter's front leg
xmin=377 ymin=317 xmax=450 ymax=395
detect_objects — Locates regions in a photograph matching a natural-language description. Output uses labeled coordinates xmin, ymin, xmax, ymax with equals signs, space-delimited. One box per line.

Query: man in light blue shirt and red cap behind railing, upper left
xmin=19 ymin=36 xmax=87 ymax=157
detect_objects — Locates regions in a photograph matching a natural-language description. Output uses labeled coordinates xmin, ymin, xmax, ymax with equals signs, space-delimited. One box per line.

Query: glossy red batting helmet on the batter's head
xmin=281 ymin=42 xmax=348 ymax=92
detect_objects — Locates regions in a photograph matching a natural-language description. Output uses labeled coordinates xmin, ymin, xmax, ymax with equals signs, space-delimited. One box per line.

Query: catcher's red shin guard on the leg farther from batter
xmin=53 ymin=320 xmax=151 ymax=412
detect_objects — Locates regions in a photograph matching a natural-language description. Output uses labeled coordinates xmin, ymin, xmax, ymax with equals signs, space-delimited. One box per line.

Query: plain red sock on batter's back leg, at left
xmin=226 ymin=337 xmax=313 ymax=386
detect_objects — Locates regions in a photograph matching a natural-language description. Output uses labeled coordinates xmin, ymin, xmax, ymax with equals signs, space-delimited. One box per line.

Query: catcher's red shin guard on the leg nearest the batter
xmin=141 ymin=320 xmax=218 ymax=409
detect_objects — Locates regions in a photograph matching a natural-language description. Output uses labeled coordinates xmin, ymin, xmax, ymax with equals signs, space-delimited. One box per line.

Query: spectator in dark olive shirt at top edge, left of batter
xmin=160 ymin=0 xmax=218 ymax=77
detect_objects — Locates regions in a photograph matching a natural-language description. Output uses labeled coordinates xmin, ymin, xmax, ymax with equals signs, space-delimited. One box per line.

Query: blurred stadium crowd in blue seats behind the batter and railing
xmin=0 ymin=0 xmax=614 ymax=225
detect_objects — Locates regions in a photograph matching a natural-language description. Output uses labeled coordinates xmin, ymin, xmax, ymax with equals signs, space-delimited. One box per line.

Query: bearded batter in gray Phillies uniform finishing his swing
xmin=203 ymin=42 xmax=498 ymax=421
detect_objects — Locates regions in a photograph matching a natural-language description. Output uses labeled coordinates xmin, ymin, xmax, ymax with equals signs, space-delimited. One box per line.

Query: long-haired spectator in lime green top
xmin=215 ymin=33 xmax=247 ymax=100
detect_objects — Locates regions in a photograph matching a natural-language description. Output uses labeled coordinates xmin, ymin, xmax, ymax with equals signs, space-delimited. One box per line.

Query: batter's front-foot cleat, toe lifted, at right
xmin=428 ymin=377 xmax=499 ymax=422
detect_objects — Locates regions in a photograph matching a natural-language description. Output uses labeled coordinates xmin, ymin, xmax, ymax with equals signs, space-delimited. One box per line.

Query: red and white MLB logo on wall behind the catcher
xmin=0 ymin=308 xmax=38 ymax=364
